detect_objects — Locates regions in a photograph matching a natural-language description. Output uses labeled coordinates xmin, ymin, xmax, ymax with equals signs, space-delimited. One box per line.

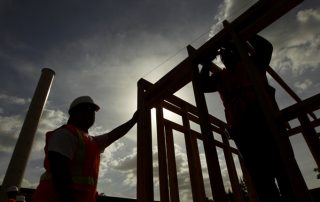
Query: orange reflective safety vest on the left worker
xmin=32 ymin=125 xmax=100 ymax=202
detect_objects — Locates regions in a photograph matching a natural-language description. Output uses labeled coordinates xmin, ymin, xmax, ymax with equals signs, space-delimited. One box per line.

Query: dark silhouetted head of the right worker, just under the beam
xmin=218 ymin=43 xmax=240 ymax=68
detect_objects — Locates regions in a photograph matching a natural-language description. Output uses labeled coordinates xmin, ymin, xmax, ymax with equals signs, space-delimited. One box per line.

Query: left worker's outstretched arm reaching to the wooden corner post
xmin=95 ymin=111 xmax=139 ymax=151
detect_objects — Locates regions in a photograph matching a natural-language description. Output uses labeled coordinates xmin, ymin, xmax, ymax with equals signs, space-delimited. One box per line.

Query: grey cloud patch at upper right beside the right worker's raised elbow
xmin=263 ymin=6 xmax=320 ymax=103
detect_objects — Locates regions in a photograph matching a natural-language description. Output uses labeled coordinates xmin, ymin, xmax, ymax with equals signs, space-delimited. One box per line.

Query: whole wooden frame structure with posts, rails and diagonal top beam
xmin=137 ymin=0 xmax=320 ymax=202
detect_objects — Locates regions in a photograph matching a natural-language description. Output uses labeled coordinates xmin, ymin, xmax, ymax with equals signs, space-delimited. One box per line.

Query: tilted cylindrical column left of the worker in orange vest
xmin=0 ymin=68 xmax=55 ymax=202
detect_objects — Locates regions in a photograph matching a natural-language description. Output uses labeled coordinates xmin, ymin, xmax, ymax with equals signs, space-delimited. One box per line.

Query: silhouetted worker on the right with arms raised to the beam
xmin=201 ymin=35 xmax=291 ymax=202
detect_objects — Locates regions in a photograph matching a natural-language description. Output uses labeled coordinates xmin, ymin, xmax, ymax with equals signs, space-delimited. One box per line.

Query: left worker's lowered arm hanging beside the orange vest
xmin=48 ymin=151 xmax=74 ymax=202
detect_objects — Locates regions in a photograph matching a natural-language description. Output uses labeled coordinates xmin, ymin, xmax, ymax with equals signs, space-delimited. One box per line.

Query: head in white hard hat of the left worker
xmin=68 ymin=96 xmax=100 ymax=132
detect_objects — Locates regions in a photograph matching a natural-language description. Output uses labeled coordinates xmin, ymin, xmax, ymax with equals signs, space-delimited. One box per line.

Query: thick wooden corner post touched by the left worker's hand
xmin=137 ymin=81 xmax=154 ymax=202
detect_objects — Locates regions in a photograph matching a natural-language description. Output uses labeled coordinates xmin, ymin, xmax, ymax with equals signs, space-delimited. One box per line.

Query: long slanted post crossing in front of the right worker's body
xmin=223 ymin=21 xmax=312 ymax=202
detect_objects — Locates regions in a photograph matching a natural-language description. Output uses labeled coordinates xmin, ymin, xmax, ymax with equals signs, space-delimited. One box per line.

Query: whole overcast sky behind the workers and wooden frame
xmin=0 ymin=0 xmax=320 ymax=201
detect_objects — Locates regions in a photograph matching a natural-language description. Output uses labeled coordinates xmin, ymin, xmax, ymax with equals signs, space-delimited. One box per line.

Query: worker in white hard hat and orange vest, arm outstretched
xmin=33 ymin=96 xmax=138 ymax=202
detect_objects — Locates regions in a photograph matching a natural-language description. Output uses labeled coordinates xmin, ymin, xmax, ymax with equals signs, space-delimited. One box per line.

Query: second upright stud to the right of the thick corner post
xmin=165 ymin=124 xmax=180 ymax=202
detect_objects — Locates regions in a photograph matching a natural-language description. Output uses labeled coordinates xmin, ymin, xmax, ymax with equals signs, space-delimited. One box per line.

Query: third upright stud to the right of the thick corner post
xmin=182 ymin=107 xmax=206 ymax=202
